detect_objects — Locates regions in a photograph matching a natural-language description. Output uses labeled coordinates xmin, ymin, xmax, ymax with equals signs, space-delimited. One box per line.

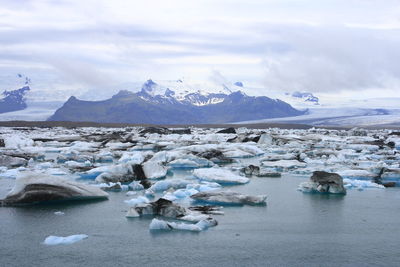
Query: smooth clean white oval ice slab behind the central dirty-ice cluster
xmin=193 ymin=168 xmax=250 ymax=184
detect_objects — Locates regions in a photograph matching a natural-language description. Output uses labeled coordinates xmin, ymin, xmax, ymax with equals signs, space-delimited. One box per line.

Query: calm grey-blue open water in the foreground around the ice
xmin=0 ymin=172 xmax=400 ymax=266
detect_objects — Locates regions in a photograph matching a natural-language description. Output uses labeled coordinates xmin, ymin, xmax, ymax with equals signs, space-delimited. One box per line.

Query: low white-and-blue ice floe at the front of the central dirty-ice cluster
xmin=149 ymin=219 xmax=216 ymax=232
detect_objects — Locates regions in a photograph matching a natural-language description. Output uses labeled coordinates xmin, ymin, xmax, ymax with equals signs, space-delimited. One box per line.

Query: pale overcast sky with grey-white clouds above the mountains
xmin=0 ymin=0 xmax=400 ymax=102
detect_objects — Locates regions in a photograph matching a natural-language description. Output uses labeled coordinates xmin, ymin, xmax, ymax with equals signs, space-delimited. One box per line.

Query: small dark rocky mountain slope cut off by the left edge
xmin=0 ymin=86 xmax=30 ymax=113
